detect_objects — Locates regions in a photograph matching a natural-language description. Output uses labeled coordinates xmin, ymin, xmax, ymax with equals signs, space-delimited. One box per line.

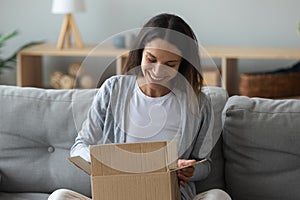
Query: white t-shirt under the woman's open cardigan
xmin=125 ymin=84 xmax=182 ymax=142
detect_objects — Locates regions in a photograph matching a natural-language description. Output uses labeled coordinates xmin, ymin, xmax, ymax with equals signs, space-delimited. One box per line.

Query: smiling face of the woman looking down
xmin=141 ymin=38 xmax=181 ymax=96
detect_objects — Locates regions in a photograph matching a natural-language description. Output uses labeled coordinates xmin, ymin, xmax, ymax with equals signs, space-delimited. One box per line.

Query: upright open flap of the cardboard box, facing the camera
xmin=90 ymin=142 xmax=177 ymax=176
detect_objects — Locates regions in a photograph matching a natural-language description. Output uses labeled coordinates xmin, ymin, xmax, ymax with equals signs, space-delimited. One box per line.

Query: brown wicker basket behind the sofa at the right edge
xmin=240 ymin=71 xmax=300 ymax=98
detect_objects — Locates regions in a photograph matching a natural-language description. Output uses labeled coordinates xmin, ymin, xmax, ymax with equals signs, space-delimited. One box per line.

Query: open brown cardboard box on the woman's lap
xmin=69 ymin=141 xmax=181 ymax=200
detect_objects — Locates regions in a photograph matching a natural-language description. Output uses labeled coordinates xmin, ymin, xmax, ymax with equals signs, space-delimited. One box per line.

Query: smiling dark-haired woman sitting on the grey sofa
xmin=49 ymin=14 xmax=230 ymax=200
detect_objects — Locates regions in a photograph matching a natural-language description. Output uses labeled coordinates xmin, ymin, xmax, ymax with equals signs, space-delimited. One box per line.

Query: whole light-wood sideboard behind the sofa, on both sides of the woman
xmin=17 ymin=44 xmax=300 ymax=96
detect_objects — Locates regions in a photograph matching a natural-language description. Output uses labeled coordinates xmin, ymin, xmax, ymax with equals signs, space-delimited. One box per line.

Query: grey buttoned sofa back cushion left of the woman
xmin=0 ymin=86 xmax=96 ymax=195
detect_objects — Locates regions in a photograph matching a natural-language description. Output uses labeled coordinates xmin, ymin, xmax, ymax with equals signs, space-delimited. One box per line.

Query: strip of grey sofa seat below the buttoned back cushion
xmin=0 ymin=192 xmax=49 ymax=200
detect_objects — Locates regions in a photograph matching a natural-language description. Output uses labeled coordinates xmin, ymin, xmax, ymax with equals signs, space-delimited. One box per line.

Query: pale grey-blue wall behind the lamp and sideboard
xmin=0 ymin=0 xmax=300 ymax=84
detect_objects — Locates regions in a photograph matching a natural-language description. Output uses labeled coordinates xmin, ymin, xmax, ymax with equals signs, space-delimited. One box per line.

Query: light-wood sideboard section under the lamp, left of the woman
xmin=17 ymin=44 xmax=128 ymax=87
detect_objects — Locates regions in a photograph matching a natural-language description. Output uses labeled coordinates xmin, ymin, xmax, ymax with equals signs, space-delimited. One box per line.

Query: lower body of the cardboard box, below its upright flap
xmin=92 ymin=172 xmax=181 ymax=200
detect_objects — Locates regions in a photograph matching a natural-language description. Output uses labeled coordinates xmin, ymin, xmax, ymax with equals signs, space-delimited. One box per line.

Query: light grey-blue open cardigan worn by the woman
xmin=71 ymin=75 xmax=213 ymax=200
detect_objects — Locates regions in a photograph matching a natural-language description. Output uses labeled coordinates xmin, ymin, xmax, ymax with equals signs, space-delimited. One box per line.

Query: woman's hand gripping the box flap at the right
xmin=177 ymin=159 xmax=196 ymax=187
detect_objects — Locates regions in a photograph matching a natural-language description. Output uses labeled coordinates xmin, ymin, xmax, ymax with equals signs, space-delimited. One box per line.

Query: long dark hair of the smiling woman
xmin=122 ymin=13 xmax=203 ymax=95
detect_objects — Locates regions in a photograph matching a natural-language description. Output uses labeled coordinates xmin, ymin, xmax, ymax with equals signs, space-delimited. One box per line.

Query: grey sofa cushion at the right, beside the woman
xmin=223 ymin=96 xmax=300 ymax=200
